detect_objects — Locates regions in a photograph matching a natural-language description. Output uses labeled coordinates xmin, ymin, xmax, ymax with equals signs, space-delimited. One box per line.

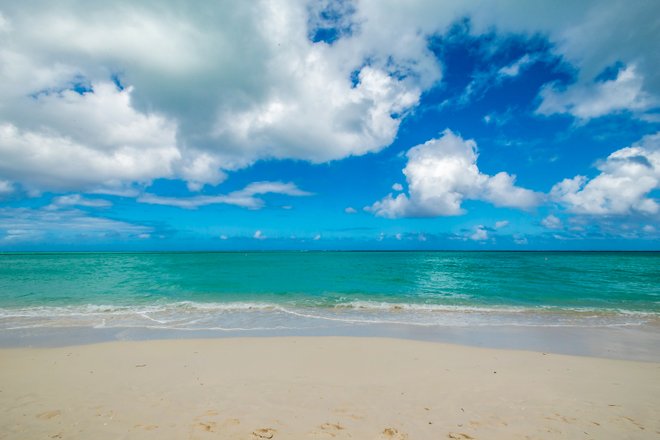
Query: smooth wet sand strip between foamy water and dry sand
xmin=0 ymin=323 xmax=660 ymax=362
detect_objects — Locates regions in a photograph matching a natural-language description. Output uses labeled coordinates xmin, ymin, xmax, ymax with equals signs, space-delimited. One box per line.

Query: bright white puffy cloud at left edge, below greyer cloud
xmin=0 ymin=83 xmax=181 ymax=191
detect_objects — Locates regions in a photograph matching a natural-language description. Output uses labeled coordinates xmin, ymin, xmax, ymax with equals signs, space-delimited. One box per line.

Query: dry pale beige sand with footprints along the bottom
xmin=0 ymin=337 xmax=660 ymax=440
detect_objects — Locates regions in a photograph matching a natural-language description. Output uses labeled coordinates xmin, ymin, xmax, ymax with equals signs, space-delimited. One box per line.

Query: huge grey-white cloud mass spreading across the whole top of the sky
xmin=0 ymin=0 xmax=660 ymax=191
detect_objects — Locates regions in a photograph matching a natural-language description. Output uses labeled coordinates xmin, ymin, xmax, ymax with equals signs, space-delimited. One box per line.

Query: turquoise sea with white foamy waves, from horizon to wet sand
xmin=0 ymin=252 xmax=660 ymax=330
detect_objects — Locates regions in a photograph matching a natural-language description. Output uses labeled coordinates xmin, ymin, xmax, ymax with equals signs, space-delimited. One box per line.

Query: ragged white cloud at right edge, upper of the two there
xmin=536 ymin=66 xmax=657 ymax=120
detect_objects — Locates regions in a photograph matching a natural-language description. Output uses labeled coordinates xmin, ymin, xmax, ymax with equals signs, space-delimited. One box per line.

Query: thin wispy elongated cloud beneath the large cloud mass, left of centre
xmin=137 ymin=182 xmax=312 ymax=209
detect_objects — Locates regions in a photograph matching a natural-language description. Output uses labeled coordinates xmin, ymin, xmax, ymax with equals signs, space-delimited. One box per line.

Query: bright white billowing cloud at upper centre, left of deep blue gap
xmin=214 ymin=64 xmax=420 ymax=162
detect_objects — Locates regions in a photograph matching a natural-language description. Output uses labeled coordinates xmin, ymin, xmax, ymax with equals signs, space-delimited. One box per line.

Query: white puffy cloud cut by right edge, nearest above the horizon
xmin=550 ymin=133 xmax=660 ymax=215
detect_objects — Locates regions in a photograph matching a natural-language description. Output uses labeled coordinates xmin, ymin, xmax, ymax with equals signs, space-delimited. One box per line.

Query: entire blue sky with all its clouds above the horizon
xmin=0 ymin=0 xmax=660 ymax=251
